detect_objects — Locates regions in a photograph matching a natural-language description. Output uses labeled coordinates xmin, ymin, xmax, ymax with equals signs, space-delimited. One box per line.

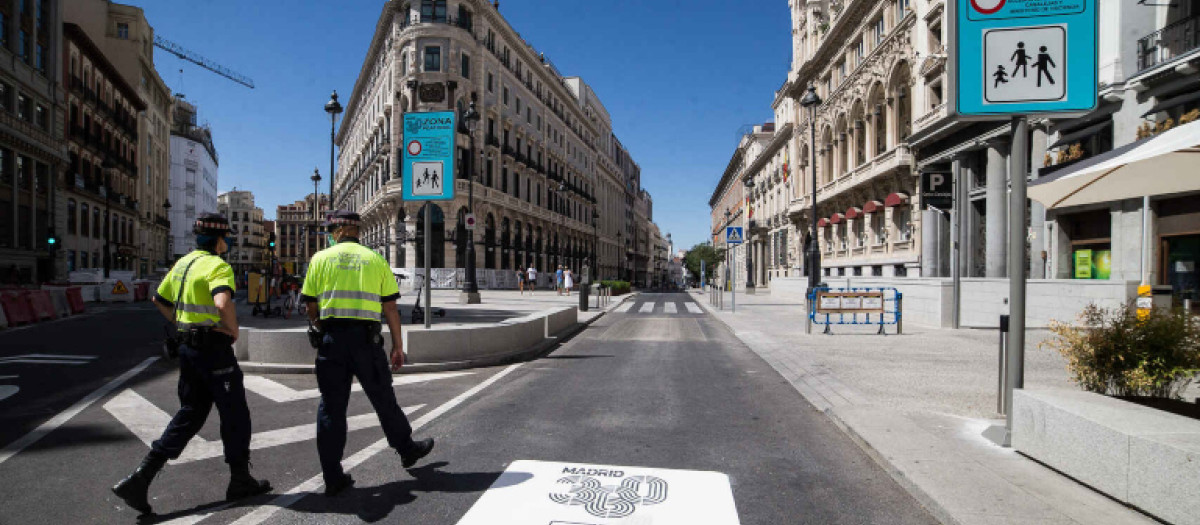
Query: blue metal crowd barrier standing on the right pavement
xmin=808 ymin=286 xmax=904 ymax=336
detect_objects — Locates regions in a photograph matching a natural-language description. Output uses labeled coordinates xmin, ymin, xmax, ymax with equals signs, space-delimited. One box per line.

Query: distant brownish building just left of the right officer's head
xmin=275 ymin=193 xmax=329 ymax=274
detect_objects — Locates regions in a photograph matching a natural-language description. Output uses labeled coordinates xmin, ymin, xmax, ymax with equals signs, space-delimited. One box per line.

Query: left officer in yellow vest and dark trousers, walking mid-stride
xmin=113 ymin=213 xmax=271 ymax=514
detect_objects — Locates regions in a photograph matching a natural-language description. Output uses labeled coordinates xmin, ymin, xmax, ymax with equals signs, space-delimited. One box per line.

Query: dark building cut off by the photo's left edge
xmin=0 ymin=0 xmax=70 ymax=285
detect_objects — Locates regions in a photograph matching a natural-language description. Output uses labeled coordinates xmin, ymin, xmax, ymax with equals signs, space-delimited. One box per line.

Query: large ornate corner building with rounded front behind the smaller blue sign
xmin=334 ymin=0 xmax=652 ymax=278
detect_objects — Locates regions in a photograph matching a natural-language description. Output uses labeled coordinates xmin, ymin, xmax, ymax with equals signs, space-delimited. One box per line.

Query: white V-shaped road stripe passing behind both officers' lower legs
xmin=104 ymin=388 xmax=425 ymax=464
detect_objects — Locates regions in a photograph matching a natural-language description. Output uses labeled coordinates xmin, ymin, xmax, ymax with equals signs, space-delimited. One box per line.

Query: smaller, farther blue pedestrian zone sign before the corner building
xmin=401 ymin=111 xmax=456 ymax=200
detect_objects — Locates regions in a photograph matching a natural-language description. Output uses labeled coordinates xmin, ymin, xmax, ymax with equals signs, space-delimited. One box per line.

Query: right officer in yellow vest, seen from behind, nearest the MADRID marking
xmin=300 ymin=211 xmax=433 ymax=496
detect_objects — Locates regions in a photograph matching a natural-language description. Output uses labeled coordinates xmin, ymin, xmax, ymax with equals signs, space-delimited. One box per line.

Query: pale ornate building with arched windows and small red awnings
xmin=772 ymin=0 xmax=921 ymax=280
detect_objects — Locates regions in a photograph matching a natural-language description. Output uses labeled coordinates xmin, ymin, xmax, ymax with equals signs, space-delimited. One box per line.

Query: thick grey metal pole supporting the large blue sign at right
xmin=1003 ymin=115 xmax=1030 ymax=446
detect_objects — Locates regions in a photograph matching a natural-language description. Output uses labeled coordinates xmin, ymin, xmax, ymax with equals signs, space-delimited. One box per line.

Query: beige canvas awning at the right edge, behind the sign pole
xmin=1028 ymin=121 xmax=1200 ymax=209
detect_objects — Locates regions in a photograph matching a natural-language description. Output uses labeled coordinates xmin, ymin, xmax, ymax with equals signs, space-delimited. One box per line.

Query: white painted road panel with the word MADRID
xmin=458 ymin=459 xmax=739 ymax=525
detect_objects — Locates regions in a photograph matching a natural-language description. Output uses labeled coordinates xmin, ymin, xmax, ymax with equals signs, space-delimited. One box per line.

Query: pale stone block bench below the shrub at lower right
xmin=1013 ymin=390 xmax=1200 ymax=525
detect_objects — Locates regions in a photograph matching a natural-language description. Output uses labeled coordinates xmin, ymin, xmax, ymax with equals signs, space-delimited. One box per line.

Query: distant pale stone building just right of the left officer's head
xmin=217 ymin=188 xmax=274 ymax=276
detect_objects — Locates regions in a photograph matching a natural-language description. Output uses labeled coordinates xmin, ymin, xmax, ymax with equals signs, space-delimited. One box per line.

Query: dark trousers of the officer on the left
xmin=150 ymin=332 xmax=250 ymax=465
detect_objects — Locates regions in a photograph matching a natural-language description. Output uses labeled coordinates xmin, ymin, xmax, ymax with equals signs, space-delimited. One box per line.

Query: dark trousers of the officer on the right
xmin=317 ymin=324 xmax=413 ymax=483
